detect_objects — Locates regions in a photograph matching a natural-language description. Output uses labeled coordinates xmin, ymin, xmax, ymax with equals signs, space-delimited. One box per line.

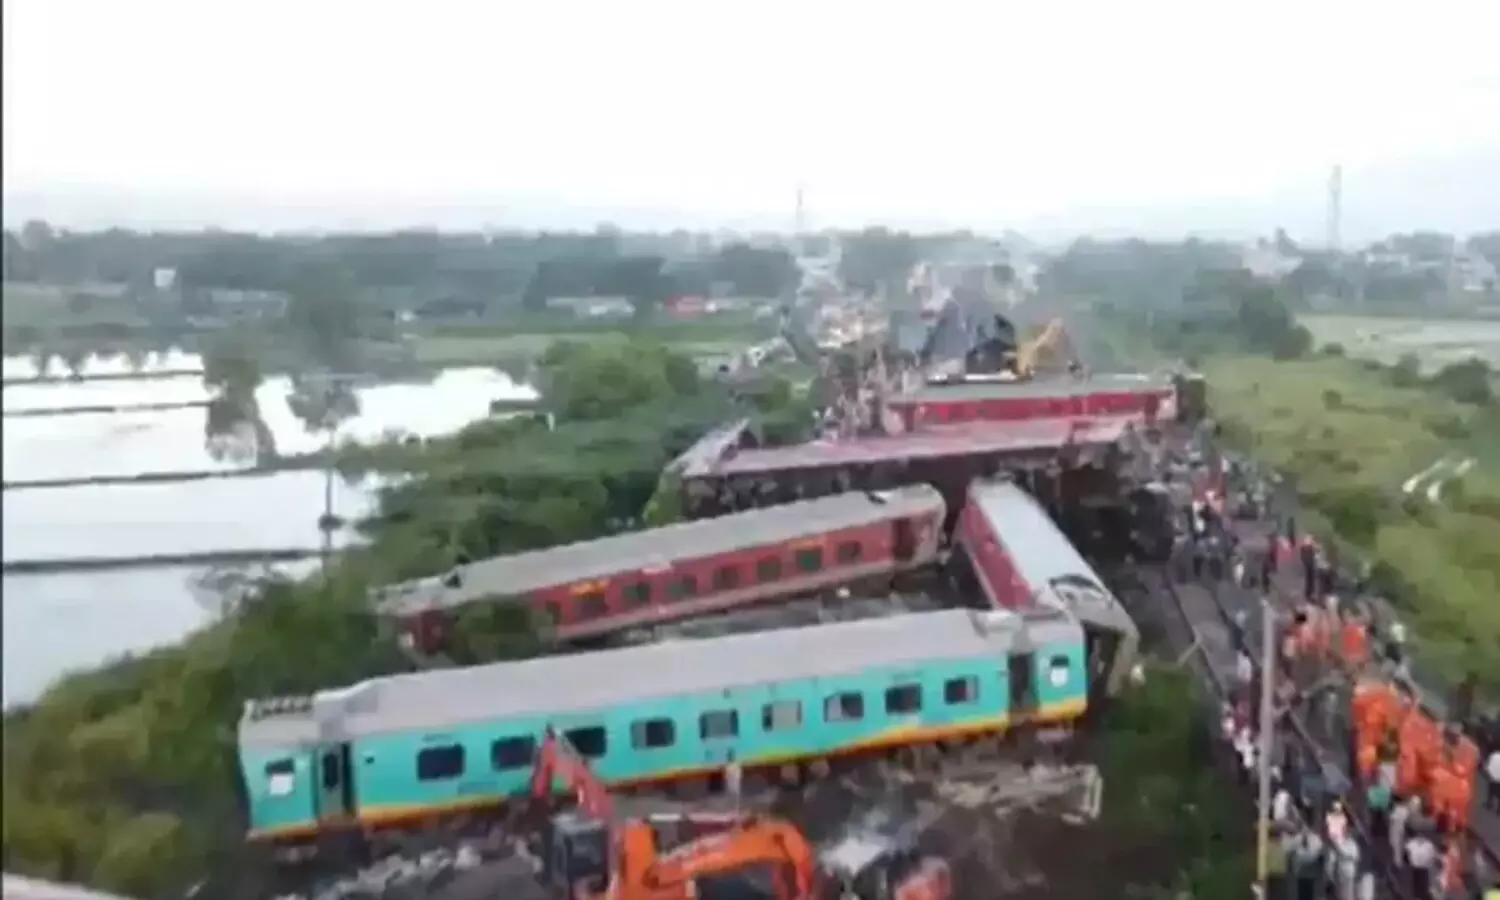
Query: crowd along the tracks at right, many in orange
xmin=1169 ymin=432 xmax=1500 ymax=900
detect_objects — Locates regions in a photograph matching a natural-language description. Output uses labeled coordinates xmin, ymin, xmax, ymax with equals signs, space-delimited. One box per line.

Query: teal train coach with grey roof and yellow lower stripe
xmin=239 ymin=605 xmax=1091 ymax=843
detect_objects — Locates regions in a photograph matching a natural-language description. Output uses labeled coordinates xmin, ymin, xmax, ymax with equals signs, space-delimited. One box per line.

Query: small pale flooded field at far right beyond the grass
xmin=1301 ymin=315 xmax=1500 ymax=372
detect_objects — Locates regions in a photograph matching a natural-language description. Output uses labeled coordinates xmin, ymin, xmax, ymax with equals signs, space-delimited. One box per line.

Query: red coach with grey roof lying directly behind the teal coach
xmin=377 ymin=485 xmax=947 ymax=653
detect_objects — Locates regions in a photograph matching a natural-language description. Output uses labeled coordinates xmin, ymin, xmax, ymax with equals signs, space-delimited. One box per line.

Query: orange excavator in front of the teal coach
xmin=531 ymin=729 xmax=953 ymax=900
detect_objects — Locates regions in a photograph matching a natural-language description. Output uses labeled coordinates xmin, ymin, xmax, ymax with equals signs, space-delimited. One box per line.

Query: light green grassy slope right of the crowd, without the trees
xmin=1205 ymin=356 xmax=1500 ymax=695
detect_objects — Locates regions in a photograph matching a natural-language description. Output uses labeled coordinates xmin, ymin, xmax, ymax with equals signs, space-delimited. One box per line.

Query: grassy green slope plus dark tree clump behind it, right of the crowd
xmin=1092 ymin=253 xmax=1500 ymax=695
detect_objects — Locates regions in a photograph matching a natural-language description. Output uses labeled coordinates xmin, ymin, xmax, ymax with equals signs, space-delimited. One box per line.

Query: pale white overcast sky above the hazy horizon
xmin=3 ymin=0 xmax=1500 ymax=228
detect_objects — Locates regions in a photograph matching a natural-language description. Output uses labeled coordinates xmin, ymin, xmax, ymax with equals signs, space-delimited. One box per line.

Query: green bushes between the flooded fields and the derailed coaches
xmin=3 ymin=342 xmax=809 ymax=897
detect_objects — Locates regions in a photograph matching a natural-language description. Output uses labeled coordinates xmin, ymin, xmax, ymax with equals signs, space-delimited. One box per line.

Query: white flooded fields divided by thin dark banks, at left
xmin=0 ymin=354 xmax=534 ymax=707
